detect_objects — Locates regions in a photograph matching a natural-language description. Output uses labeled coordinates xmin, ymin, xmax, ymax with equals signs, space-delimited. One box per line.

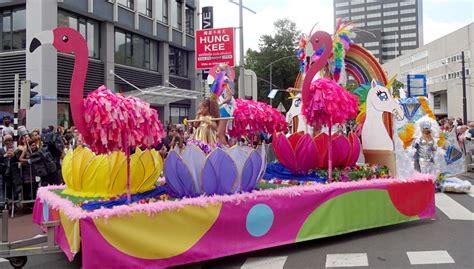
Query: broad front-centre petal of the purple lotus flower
xmin=201 ymin=148 xmax=237 ymax=195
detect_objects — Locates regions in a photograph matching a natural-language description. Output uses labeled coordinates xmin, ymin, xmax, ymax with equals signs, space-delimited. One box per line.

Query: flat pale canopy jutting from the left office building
xmin=124 ymin=86 xmax=203 ymax=105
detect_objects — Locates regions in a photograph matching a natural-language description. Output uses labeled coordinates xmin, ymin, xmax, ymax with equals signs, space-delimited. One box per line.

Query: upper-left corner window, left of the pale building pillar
xmin=0 ymin=7 xmax=26 ymax=52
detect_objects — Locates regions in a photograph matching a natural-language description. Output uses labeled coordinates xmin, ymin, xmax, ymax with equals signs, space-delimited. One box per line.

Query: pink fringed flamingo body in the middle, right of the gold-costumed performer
xmin=229 ymin=99 xmax=287 ymax=137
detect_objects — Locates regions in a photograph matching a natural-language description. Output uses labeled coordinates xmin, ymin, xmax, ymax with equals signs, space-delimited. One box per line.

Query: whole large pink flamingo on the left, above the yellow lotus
xmin=29 ymin=27 xmax=165 ymax=201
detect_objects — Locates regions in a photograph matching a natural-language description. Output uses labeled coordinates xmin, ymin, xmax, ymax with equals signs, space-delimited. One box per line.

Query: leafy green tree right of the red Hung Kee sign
xmin=245 ymin=19 xmax=301 ymax=109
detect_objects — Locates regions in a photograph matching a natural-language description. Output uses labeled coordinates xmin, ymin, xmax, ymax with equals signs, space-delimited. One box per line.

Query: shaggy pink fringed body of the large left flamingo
xmin=84 ymin=86 xmax=165 ymax=154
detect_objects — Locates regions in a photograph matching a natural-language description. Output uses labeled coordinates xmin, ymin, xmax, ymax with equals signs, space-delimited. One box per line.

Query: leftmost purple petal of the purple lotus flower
xmin=164 ymin=150 xmax=196 ymax=197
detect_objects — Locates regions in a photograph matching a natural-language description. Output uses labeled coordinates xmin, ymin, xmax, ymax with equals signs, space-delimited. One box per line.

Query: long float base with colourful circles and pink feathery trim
xmin=33 ymin=174 xmax=436 ymax=268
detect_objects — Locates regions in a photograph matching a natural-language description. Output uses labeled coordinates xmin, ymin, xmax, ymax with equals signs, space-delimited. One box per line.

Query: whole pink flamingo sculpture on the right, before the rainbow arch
xmin=302 ymin=31 xmax=358 ymax=182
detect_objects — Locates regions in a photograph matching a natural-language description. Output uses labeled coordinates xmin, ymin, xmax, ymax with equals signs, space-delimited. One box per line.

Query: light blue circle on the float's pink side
xmin=246 ymin=204 xmax=275 ymax=237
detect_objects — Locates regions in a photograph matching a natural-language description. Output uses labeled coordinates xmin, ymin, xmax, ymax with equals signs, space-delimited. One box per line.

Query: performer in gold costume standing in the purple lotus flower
xmin=193 ymin=97 xmax=220 ymax=144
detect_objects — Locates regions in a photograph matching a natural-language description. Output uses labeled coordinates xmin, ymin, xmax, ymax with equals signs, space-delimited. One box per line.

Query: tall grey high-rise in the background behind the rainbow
xmin=334 ymin=0 xmax=423 ymax=63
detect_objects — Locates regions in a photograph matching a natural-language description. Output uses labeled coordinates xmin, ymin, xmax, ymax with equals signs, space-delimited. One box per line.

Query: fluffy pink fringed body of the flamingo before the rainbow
xmin=302 ymin=78 xmax=359 ymax=126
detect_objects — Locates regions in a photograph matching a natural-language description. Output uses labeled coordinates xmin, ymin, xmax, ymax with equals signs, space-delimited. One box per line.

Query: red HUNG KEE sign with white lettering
xmin=196 ymin=28 xmax=234 ymax=69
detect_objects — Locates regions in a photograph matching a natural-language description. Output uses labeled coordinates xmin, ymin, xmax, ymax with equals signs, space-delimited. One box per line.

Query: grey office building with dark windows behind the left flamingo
xmin=0 ymin=0 xmax=201 ymax=128
